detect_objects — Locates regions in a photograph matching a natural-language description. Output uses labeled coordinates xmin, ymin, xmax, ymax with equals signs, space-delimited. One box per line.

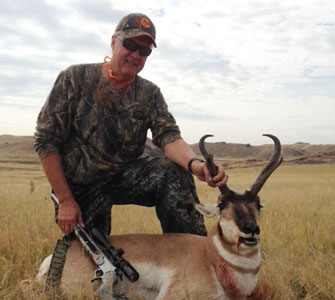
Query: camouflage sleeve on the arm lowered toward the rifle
xmin=34 ymin=71 xmax=74 ymax=159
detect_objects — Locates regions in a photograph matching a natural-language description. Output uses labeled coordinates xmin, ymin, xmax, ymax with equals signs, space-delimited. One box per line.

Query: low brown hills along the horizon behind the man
xmin=0 ymin=135 xmax=335 ymax=163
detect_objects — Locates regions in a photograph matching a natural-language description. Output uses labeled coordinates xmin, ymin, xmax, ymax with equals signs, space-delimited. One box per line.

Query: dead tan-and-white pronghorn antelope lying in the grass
xmin=22 ymin=135 xmax=282 ymax=300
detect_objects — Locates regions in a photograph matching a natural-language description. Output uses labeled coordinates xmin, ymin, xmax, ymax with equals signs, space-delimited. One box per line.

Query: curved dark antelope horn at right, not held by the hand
xmin=250 ymin=134 xmax=283 ymax=196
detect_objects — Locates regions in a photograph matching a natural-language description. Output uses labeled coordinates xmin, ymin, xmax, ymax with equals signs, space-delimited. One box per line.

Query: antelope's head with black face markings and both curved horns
xmin=196 ymin=134 xmax=282 ymax=249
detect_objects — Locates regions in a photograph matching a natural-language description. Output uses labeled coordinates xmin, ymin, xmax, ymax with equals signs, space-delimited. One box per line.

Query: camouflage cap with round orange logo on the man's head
xmin=115 ymin=13 xmax=157 ymax=47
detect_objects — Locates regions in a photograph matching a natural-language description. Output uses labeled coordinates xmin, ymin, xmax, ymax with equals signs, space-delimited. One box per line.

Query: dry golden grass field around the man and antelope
xmin=0 ymin=162 xmax=335 ymax=300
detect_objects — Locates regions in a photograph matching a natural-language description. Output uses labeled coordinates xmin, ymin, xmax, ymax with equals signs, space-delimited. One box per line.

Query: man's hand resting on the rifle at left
xmin=57 ymin=200 xmax=85 ymax=235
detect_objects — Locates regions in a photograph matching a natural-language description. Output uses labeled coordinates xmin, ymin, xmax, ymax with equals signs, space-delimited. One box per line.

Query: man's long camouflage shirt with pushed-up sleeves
xmin=34 ymin=63 xmax=181 ymax=184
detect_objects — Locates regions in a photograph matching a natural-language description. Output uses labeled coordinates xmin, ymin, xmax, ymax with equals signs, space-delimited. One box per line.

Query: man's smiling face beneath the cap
xmin=111 ymin=33 xmax=152 ymax=81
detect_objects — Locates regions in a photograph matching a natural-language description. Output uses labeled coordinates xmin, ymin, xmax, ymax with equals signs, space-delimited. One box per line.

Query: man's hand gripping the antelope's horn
xmin=191 ymin=160 xmax=228 ymax=187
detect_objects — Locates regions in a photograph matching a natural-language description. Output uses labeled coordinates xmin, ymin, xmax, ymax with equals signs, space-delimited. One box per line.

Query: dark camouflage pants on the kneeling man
xmin=53 ymin=157 xmax=206 ymax=235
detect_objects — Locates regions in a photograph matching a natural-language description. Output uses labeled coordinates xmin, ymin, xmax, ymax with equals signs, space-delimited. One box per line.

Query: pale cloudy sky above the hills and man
xmin=0 ymin=0 xmax=335 ymax=145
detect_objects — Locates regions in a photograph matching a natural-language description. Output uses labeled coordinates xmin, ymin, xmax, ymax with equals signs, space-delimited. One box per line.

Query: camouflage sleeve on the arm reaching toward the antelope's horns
xmin=151 ymin=88 xmax=181 ymax=148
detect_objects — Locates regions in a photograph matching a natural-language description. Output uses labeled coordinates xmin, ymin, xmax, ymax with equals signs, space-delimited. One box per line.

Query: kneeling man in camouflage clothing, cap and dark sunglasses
xmin=35 ymin=14 xmax=228 ymax=235
